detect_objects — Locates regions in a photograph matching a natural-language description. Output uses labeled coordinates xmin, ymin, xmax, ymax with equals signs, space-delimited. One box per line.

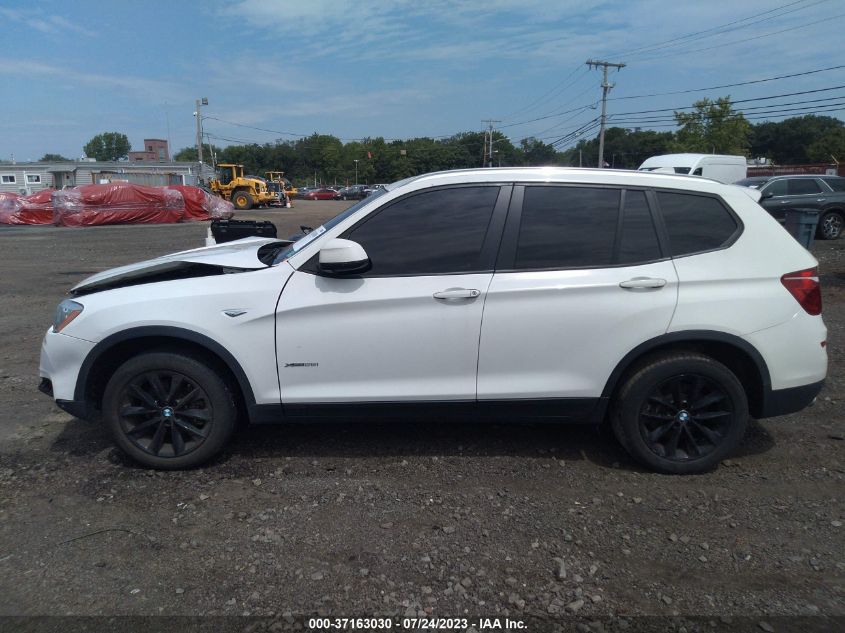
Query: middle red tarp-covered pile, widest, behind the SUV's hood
xmin=53 ymin=183 xmax=185 ymax=226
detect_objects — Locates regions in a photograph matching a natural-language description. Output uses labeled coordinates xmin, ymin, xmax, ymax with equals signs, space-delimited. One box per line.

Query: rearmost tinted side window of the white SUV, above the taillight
xmin=657 ymin=192 xmax=737 ymax=257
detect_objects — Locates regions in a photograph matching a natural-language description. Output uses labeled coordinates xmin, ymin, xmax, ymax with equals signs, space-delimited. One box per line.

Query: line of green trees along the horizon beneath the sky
xmin=42 ymin=97 xmax=845 ymax=186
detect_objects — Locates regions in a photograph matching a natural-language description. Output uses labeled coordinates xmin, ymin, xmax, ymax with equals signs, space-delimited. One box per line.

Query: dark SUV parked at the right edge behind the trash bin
xmin=760 ymin=175 xmax=845 ymax=240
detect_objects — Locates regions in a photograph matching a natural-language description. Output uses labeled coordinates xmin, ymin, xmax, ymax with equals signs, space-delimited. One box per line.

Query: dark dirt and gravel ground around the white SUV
xmin=0 ymin=201 xmax=845 ymax=631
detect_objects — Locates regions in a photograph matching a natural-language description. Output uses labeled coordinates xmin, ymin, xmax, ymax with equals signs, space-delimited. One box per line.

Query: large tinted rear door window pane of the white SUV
xmin=514 ymin=187 xmax=619 ymax=269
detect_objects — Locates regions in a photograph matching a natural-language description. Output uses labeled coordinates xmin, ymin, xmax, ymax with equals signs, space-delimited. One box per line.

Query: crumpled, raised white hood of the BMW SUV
xmin=70 ymin=237 xmax=290 ymax=296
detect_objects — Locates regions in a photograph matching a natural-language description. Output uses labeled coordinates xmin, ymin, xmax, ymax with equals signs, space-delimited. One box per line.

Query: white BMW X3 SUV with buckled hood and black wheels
xmin=40 ymin=168 xmax=827 ymax=473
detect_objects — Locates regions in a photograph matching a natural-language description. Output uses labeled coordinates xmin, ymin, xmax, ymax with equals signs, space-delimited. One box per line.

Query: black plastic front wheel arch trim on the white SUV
xmin=74 ymin=325 xmax=255 ymax=407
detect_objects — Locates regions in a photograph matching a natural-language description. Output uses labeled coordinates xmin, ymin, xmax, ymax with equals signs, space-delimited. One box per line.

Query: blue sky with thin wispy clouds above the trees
xmin=0 ymin=0 xmax=845 ymax=162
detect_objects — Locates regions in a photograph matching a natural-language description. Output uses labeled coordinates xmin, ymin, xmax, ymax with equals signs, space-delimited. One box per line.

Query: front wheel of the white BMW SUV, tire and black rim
xmin=103 ymin=352 xmax=237 ymax=470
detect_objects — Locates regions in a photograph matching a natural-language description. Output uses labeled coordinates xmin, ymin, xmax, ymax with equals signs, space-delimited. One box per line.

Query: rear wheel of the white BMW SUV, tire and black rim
xmin=611 ymin=353 xmax=748 ymax=475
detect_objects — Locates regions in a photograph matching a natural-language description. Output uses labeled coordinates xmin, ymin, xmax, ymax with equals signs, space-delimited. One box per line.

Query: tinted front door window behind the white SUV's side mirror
xmin=346 ymin=187 xmax=499 ymax=275
